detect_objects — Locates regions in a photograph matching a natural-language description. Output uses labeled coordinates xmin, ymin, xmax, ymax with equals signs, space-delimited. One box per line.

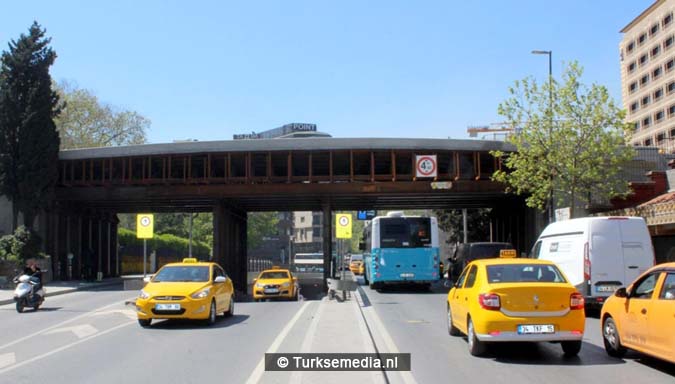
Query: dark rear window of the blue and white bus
xmin=380 ymin=217 xmax=431 ymax=248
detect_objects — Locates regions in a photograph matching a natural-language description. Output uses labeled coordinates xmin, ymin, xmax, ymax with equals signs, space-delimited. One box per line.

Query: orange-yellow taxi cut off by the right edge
xmin=600 ymin=263 xmax=675 ymax=363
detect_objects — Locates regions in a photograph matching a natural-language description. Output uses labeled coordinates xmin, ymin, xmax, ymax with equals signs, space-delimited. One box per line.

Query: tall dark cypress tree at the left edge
xmin=0 ymin=22 xmax=59 ymax=228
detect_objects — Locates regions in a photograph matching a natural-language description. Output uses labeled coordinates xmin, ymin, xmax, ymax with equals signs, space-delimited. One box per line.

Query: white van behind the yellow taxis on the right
xmin=530 ymin=216 xmax=654 ymax=307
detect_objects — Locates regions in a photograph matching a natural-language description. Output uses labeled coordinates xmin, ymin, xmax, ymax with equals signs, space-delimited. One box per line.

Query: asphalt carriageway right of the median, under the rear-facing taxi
xmin=358 ymin=277 xmax=675 ymax=384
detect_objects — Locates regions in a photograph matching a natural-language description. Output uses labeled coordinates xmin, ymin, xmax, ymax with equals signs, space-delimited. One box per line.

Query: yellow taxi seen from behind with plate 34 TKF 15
xmin=447 ymin=259 xmax=586 ymax=356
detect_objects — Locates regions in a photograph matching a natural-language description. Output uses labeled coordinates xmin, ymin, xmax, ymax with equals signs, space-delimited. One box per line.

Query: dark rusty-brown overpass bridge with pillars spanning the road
xmin=46 ymin=137 xmax=536 ymax=292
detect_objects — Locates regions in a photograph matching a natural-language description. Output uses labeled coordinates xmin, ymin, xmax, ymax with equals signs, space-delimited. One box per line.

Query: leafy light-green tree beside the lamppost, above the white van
xmin=492 ymin=62 xmax=634 ymax=217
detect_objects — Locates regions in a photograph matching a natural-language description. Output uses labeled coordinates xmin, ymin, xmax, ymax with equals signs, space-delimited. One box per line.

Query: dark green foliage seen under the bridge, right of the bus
xmin=434 ymin=208 xmax=491 ymax=244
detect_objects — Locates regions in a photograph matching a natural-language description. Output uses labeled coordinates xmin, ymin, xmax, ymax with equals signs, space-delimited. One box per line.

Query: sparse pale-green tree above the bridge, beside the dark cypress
xmin=55 ymin=81 xmax=150 ymax=149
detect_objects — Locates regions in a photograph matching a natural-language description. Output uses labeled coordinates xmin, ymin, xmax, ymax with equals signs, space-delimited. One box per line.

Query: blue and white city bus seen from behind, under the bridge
xmin=362 ymin=212 xmax=440 ymax=289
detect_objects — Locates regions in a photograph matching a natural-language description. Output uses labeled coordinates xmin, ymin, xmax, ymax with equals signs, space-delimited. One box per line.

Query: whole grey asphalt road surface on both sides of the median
xmin=0 ymin=280 xmax=675 ymax=384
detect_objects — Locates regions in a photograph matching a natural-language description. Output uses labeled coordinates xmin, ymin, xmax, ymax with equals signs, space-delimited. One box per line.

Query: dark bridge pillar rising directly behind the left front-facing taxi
xmin=213 ymin=201 xmax=248 ymax=292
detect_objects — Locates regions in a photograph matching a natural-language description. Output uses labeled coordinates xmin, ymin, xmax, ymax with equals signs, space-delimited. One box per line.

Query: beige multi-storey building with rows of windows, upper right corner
xmin=619 ymin=0 xmax=675 ymax=153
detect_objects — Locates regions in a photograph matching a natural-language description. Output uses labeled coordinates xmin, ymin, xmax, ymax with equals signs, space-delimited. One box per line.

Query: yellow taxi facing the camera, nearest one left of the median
xmin=136 ymin=258 xmax=234 ymax=327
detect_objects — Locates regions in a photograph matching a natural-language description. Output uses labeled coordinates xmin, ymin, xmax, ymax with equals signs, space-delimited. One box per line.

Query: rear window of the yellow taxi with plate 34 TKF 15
xmin=487 ymin=263 xmax=567 ymax=284
